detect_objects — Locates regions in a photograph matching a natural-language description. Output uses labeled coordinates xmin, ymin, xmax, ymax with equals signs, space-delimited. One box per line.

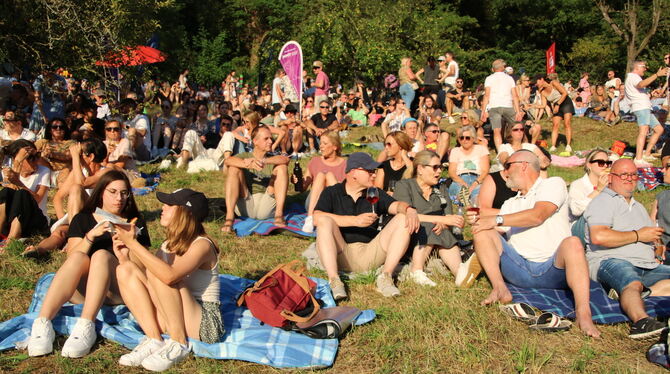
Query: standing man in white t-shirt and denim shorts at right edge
xmin=624 ymin=61 xmax=668 ymax=167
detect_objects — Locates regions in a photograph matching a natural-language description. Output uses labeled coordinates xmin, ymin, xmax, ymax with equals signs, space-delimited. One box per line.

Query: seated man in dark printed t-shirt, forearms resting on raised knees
xmin=221 ymin=126 xmax=289 ymax=232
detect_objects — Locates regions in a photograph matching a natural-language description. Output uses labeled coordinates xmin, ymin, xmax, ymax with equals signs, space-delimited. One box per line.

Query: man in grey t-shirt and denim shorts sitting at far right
xmin=584 ymin=159 xmax=670 ymax=339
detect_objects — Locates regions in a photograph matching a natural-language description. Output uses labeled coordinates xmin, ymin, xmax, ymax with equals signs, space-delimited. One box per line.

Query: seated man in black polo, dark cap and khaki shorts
xmin=314 ymin=152 xmax=419 ymax=300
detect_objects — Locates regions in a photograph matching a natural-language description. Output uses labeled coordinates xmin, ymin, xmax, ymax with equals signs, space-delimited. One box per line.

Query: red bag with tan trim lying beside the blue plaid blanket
xmin=237 ymin=260 xmax=320 ymax=329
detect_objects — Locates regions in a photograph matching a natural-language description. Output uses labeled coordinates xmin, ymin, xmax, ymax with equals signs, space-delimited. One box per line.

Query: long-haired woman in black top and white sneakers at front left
xmin=28 ymin=170 xmax=151 ymax=358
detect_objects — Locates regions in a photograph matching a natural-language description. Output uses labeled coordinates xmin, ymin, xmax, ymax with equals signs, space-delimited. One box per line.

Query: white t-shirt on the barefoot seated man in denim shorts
xmin=500 ymin=177 xmax=571 ymax=262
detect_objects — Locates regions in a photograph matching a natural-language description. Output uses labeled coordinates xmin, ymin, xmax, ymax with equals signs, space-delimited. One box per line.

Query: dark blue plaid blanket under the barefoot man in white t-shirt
xmin=507 ymin=281 xmax=670 ymax=324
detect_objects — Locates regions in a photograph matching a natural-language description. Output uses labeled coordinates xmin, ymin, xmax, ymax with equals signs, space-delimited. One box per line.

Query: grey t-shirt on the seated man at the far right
xmin=584 ymin=188 xmax=658 ymax=281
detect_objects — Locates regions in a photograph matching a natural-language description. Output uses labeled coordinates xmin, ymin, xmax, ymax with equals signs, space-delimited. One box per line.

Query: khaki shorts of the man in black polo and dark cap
xmin=337 ymin=234 xmax=386 ymax=273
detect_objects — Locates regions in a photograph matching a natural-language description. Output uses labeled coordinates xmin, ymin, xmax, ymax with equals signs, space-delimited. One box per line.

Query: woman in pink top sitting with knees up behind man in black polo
xmin=291 ymin=131 xmax=347 ymax=232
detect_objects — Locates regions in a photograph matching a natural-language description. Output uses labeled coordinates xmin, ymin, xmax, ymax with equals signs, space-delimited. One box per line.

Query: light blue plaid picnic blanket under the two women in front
xmin=0 ymin=273 xmax=376 ymax=368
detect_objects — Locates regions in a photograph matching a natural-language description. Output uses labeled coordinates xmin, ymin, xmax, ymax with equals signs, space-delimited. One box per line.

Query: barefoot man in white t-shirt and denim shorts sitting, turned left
xmin=469 ymin=150 xmax=600 ymax=337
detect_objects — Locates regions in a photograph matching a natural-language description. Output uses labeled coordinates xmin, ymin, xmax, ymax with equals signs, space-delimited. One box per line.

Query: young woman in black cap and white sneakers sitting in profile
xmin=114 ymin=189 xmax=224 ymax=371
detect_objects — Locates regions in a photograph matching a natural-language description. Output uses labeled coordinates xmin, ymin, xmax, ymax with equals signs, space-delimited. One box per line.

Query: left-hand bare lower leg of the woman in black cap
xmin=116 ymin=261 xmax=163 ymax=340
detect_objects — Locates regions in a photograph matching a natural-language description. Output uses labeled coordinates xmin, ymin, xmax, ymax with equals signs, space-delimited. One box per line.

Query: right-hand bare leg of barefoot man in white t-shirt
xmin=555 ymin=236 xmax=600 ymax=338
